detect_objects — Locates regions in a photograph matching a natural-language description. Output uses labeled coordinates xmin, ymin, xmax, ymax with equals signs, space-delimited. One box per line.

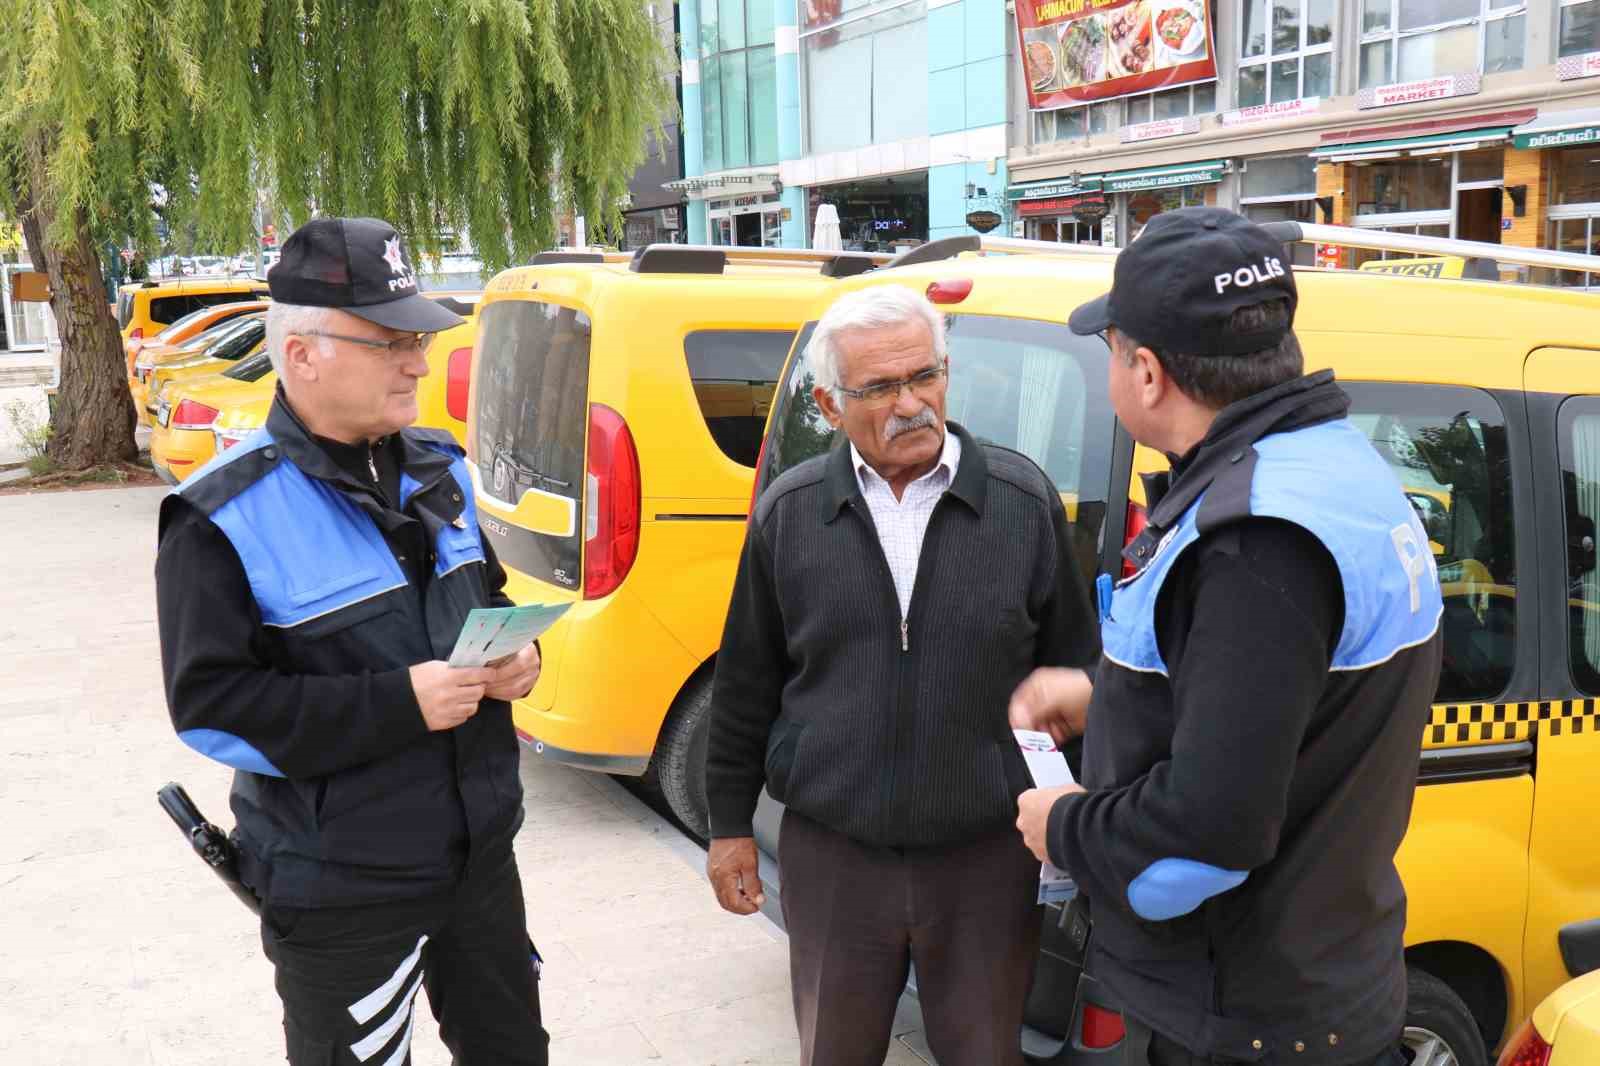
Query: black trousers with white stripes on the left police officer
xmin=261 ymin=850 xmax=550 ymax=1066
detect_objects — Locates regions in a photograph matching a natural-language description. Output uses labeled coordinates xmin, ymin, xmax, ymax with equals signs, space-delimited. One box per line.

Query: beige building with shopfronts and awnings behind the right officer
xmin=1008 ymin=0 xmax=1600 ymax=285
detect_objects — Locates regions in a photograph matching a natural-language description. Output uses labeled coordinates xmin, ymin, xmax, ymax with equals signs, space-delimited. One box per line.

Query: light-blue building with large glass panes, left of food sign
xmin=675 ymin=0 xmax=1011 ymax=251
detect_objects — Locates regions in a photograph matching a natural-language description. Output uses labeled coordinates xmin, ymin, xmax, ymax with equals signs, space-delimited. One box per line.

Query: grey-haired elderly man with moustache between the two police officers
xmin=706 ymin=285 xmax=1098 ymax=1066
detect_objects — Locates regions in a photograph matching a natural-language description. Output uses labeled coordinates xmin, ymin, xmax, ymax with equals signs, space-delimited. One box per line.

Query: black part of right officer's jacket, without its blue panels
xmin=1050 ymin=375 xmax=1440 ymax=1066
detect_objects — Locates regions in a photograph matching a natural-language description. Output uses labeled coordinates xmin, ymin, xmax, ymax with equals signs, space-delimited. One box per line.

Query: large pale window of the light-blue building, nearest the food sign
xmin=800 ymin=0 xmax=928 ymax=154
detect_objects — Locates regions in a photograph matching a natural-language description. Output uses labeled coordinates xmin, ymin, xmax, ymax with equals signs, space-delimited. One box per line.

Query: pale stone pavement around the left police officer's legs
xmin=0 ymin=488 xmax=923 ymax=1066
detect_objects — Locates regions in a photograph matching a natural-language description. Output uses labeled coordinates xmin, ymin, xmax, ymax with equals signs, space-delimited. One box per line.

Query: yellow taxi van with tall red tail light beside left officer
xmin=467 ymin=245 xmax=886 ymax=834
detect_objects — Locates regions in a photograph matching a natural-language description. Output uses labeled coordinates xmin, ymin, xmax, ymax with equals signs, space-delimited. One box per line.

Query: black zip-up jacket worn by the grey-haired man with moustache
xmin=706 ymin=423 xmax=1098 ymax=847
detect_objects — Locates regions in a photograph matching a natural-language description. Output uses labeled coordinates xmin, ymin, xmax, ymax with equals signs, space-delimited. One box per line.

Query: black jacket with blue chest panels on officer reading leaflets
xmin=157 ymin=395 xmax=522 ymax=906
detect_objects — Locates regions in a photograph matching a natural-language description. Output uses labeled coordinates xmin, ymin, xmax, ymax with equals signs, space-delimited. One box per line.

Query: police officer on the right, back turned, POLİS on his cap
xmin=1011 ymin=208 xmax=1442 ymax=1066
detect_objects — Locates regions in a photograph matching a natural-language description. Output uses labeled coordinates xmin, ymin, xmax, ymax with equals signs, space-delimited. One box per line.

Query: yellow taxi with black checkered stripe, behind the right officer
xmin=745 ymin=222 xmax=1600 ymax=1066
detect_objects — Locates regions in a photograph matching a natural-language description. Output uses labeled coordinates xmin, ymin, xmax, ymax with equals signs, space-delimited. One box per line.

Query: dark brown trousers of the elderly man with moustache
xmin=778 ymin=810 xmax=1040 ymax=1066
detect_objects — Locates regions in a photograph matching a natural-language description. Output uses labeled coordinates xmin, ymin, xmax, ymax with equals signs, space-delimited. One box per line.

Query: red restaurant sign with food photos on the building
xmin=1016 ymin=0 xmax=1216 ymax=110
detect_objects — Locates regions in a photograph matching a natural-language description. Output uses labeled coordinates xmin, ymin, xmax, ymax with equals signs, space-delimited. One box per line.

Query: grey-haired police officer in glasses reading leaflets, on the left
xmin=155 ymin=218 xmax=549 ymax=1066
